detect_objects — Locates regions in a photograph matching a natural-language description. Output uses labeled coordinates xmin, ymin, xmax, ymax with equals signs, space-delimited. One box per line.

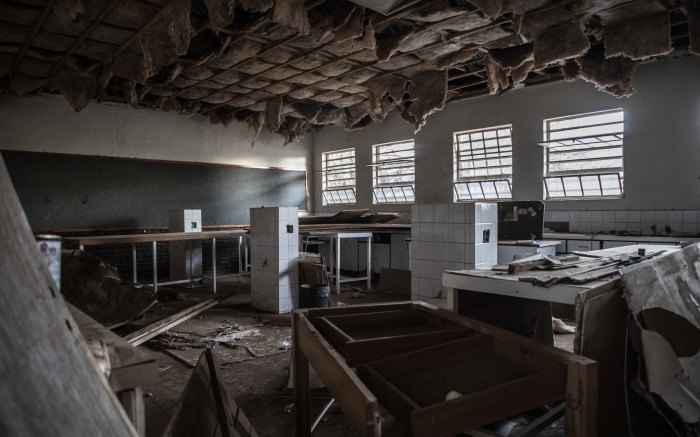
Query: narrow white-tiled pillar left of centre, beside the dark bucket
xmin=250 ymin=207 xmax=299 ymax=314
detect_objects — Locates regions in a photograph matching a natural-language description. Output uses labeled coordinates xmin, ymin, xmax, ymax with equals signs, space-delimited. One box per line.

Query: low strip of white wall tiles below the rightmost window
xmin=544 ymin=209 xmax=700 ymax=236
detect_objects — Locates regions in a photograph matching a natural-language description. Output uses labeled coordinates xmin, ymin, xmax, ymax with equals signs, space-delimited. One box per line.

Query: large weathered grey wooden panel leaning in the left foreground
xmin=0 ymin=155 xmax=137 ymax=436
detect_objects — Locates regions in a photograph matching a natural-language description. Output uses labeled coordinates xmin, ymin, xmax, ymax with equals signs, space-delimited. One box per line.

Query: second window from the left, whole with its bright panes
xmin=372 ymin=140 xmax=416 ymax=204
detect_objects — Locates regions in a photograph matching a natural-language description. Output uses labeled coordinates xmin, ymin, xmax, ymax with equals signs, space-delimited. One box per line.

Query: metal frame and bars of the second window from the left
xmin=371 ymin=139 xmax=416 ymax=205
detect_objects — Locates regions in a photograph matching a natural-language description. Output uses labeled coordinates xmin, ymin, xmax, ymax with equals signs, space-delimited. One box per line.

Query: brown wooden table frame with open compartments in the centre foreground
xmin=293 ymin=302 xmax=597 ymax=437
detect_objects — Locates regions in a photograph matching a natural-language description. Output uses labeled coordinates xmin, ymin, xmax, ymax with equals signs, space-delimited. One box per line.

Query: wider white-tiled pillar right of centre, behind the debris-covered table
xmin=411 ymin=203 xmax=498 ymax=305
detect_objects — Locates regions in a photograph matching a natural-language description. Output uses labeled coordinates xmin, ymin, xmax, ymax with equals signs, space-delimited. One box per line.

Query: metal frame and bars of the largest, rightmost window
xmin=539 ymin=108 xmax=625 ymax=200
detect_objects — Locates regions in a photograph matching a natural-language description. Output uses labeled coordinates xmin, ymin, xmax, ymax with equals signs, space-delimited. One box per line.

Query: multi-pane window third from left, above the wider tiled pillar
xmin=454 ymin=125 xmax=513 ymax=202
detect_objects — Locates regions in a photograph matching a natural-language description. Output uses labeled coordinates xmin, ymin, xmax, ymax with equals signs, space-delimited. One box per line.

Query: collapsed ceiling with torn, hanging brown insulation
xmin=0 ymin=0 xmax=700 ymax=142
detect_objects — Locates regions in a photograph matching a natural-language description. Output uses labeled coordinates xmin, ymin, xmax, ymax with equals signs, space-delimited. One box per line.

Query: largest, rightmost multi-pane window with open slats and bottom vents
xmin=540 ymin=109 xmax=624 ymax=199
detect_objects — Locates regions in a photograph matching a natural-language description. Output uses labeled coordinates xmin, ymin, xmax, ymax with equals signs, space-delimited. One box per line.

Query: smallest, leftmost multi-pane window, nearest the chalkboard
xmin=321 ymin=149 xmax=356 ymax=206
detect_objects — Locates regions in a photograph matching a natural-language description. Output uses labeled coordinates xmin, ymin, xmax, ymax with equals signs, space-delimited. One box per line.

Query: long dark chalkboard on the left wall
xmin=2 ymin=151 xmax=306 ymax=230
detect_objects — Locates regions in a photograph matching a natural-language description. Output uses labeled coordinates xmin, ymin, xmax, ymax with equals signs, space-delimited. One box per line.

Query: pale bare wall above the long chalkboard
xmin=0 ymin=95 xmax=313 ymax=208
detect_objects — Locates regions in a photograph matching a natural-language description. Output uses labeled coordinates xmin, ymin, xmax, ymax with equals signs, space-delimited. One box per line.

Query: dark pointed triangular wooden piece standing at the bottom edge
xmin=163 ymin=348 xmax=258 ymax=437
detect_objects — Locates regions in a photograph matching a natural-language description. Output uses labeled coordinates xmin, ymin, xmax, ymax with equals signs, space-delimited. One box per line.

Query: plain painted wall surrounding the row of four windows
xmin=314 ymin=57 xmax=700 ymax=213
